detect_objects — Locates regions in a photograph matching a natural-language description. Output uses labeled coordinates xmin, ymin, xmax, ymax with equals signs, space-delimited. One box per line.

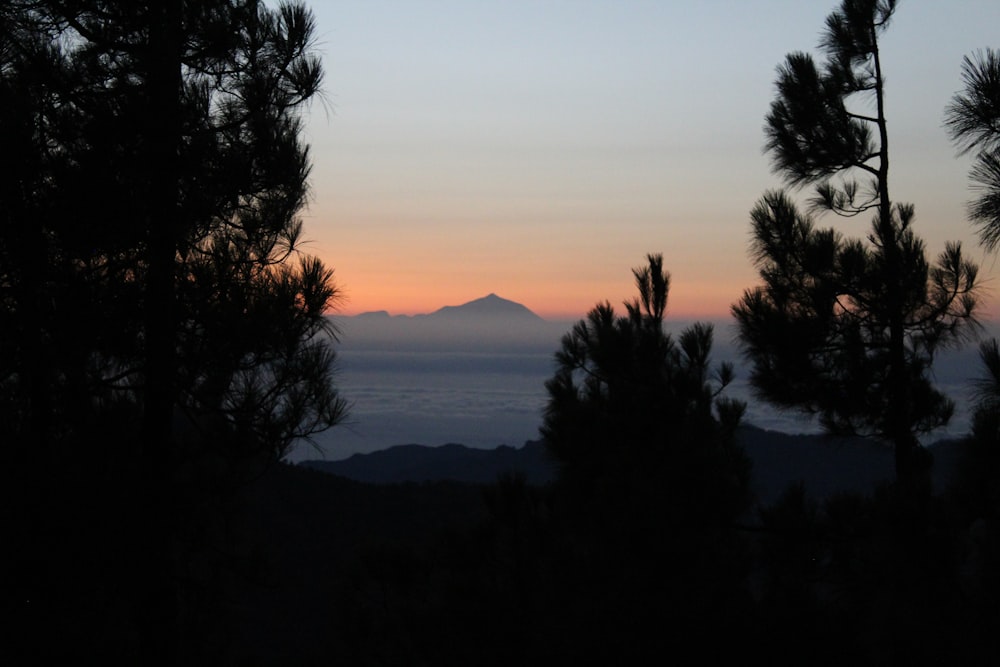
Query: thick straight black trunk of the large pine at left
xmin=136 ymin=0 xmax=182 ymax=665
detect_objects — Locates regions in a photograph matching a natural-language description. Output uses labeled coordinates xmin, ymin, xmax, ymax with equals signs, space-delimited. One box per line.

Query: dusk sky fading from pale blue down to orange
xmin=303 ymin=0 xmax=1000 ymax=319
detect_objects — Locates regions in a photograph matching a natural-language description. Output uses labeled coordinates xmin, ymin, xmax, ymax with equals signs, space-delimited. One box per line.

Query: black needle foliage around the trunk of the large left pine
xmin=2 ymin=2 xmax=344 ymax=456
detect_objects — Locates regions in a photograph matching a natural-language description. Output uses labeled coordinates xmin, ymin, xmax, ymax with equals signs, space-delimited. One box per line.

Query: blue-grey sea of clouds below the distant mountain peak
xmin=289 ymin=321 xmax=981 ymax=461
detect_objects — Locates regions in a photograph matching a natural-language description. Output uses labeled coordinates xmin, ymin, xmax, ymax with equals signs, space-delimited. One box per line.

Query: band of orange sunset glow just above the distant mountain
xmin=314 ymin=226 xmax=752 ymax=320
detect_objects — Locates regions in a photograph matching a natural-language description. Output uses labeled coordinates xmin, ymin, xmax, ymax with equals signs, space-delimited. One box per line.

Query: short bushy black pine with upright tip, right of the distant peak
xmin=542 ymin=255 xmax=749 ymax=662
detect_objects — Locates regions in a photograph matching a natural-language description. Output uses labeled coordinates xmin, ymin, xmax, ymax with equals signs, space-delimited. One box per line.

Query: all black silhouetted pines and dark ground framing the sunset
xmin=0 ymin=0 xmax=1000 ymax=665
